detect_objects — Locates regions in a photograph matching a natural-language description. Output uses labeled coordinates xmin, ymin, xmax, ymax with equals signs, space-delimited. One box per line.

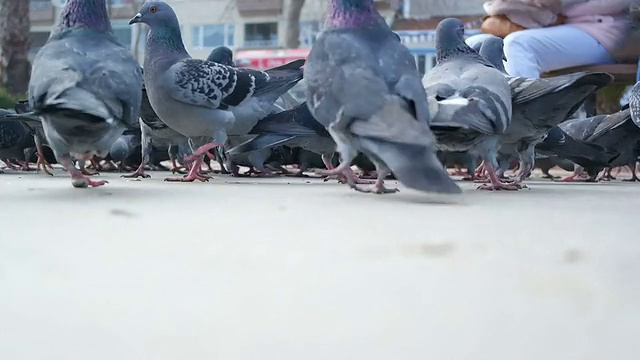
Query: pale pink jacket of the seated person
xmin=562 ymin=0 xmax=634 ymax=52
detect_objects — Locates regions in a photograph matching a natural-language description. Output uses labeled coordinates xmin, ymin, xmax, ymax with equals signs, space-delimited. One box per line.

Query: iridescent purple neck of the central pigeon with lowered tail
xmin=325 ymin=0 xmax=386 ymax=29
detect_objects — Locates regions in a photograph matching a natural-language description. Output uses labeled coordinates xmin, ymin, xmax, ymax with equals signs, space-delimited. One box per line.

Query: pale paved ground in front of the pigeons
xmin=0 ymin=169 xmax=640 ymax=360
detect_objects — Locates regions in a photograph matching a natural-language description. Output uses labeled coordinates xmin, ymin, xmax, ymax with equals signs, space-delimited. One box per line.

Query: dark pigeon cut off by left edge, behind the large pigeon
xmin=0 ymin=109 xmax=35 ymax=172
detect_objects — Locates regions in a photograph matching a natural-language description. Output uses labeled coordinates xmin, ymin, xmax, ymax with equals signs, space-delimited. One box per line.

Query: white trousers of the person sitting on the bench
xmin=467 ymin=25 xmax=615 ymax=78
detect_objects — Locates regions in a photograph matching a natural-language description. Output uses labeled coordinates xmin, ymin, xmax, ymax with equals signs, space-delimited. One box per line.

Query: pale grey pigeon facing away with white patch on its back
xmin=422 ymin=18 xmax=519 ymax=190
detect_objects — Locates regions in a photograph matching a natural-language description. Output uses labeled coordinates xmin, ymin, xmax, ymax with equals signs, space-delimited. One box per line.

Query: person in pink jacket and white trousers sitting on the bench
xmin=467 ymin=0 xmax=632 ymax=78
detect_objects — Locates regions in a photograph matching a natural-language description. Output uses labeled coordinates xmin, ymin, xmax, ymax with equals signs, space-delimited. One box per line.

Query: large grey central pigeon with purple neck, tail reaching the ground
xmin=304 ymin=0 xmax=462 ymax=194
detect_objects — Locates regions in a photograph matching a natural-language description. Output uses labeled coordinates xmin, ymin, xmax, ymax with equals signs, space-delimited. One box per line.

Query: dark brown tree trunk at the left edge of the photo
xmin=0 ymin=0 xmax=31 ymax=96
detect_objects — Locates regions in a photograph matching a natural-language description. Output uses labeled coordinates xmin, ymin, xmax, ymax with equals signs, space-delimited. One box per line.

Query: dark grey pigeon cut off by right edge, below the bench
xmin=559 ymin=107 xmax=640 ymax=182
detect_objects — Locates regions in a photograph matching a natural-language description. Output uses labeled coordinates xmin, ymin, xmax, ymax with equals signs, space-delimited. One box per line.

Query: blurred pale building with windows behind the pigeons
xmin=29 ymin=0 xmax=485 ymax=73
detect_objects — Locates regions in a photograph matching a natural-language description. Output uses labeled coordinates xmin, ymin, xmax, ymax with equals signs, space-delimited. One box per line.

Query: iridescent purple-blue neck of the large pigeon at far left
xmin=58 ymin=0 xmax=111 ymax=31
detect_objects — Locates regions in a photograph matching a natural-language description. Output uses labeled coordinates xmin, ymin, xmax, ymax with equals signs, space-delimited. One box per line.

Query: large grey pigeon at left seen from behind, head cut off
xmin=23 ymin=0 xmax=142 ymax=187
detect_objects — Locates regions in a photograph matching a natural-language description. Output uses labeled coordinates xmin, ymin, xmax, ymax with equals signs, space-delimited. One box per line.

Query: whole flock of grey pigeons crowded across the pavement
xmin=0 ymin=0 xmax=640 ymax=194
